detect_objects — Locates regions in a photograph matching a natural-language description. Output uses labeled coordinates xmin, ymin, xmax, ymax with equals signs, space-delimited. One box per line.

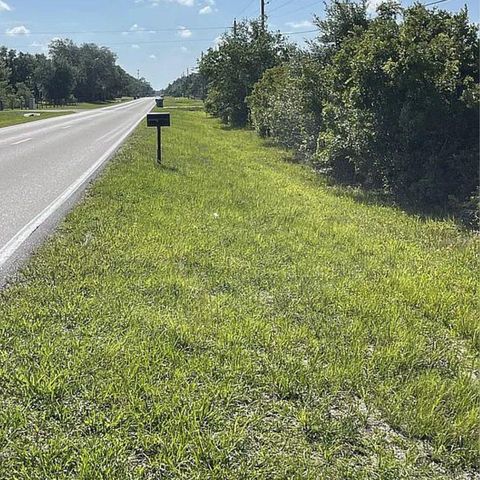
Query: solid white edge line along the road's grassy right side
xmin=0 ymin=100 xmax=150 ymax=268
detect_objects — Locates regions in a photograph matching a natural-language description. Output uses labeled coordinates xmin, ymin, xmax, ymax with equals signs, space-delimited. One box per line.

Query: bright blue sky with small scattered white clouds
xmin=0 ymin=0 xmax=479 ymax=88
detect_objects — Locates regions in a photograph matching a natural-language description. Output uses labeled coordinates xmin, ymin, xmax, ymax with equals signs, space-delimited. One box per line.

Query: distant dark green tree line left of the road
xmin=0 ymin=39 xmax=154 ymax=108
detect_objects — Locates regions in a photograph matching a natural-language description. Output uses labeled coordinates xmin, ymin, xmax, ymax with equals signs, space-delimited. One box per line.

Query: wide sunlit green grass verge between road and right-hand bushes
xmin=0 ymin=96 xmax=480 ymax=480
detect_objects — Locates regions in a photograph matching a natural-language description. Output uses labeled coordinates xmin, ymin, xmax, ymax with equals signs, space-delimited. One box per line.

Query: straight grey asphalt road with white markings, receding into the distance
xmin=0 ymin=98 xmax=155 ymax=285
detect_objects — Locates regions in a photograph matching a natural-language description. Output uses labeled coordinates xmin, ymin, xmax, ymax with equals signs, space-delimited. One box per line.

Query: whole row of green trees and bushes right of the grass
xmin=167 ymin=0 xmax=480 ymax=222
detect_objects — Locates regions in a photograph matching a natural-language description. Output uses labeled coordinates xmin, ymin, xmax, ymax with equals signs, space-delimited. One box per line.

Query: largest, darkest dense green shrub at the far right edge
xmin=318 ymin=4 xmax=478 ymax=205
